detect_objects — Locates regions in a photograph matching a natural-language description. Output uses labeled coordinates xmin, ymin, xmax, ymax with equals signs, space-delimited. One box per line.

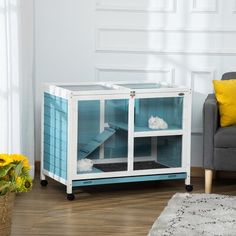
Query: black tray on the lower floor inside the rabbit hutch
xmin=93 ymin=161 xmax=168 ymax=172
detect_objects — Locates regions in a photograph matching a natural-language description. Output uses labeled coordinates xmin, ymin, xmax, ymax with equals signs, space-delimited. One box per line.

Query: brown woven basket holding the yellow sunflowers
xmin=0 ymin=193 xmax=15 ymax=236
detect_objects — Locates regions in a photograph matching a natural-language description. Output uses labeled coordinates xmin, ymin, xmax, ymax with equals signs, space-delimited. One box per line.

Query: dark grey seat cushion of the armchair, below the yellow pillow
xmin=214 ymin=125 xmax=236 ymax=148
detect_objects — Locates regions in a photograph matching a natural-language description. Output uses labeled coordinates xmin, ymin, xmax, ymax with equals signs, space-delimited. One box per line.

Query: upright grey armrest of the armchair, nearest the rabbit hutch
xmin=203 ymin=94 xmax=219 ymax=169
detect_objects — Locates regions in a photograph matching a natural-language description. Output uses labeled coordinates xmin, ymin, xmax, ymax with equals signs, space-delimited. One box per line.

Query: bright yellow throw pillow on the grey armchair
xmin=213 ymin=79 xmax=236 ymax=127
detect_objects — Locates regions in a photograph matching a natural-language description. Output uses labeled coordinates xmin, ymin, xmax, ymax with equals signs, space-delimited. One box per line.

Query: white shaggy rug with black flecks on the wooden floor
xmin=149 ymin=193 xmax=236 ymax=236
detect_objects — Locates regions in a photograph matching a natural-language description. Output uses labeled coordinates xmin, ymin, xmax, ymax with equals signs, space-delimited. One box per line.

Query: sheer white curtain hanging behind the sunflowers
xmin=0 ymin=0 xmax=34 ymax=175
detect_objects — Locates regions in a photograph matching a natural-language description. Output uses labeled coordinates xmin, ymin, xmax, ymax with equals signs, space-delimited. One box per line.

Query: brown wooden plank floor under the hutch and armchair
xmin=12 ymin=174 xmax=236 ymax=236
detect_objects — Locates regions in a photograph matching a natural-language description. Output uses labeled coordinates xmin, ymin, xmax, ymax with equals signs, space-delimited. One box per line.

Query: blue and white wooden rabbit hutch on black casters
xmin=41 ymin=81 xmax=192 ymax=200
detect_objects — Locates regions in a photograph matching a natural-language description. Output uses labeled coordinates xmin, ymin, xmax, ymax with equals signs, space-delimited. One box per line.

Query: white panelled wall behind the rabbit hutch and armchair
xmin=35 ymin=0 xmax=236 ymax=166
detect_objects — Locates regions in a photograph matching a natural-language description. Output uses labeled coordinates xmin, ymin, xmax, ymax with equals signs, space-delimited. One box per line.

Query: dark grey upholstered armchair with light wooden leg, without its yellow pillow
xmin=203 ymin=72 xmax=236 ymax=193
